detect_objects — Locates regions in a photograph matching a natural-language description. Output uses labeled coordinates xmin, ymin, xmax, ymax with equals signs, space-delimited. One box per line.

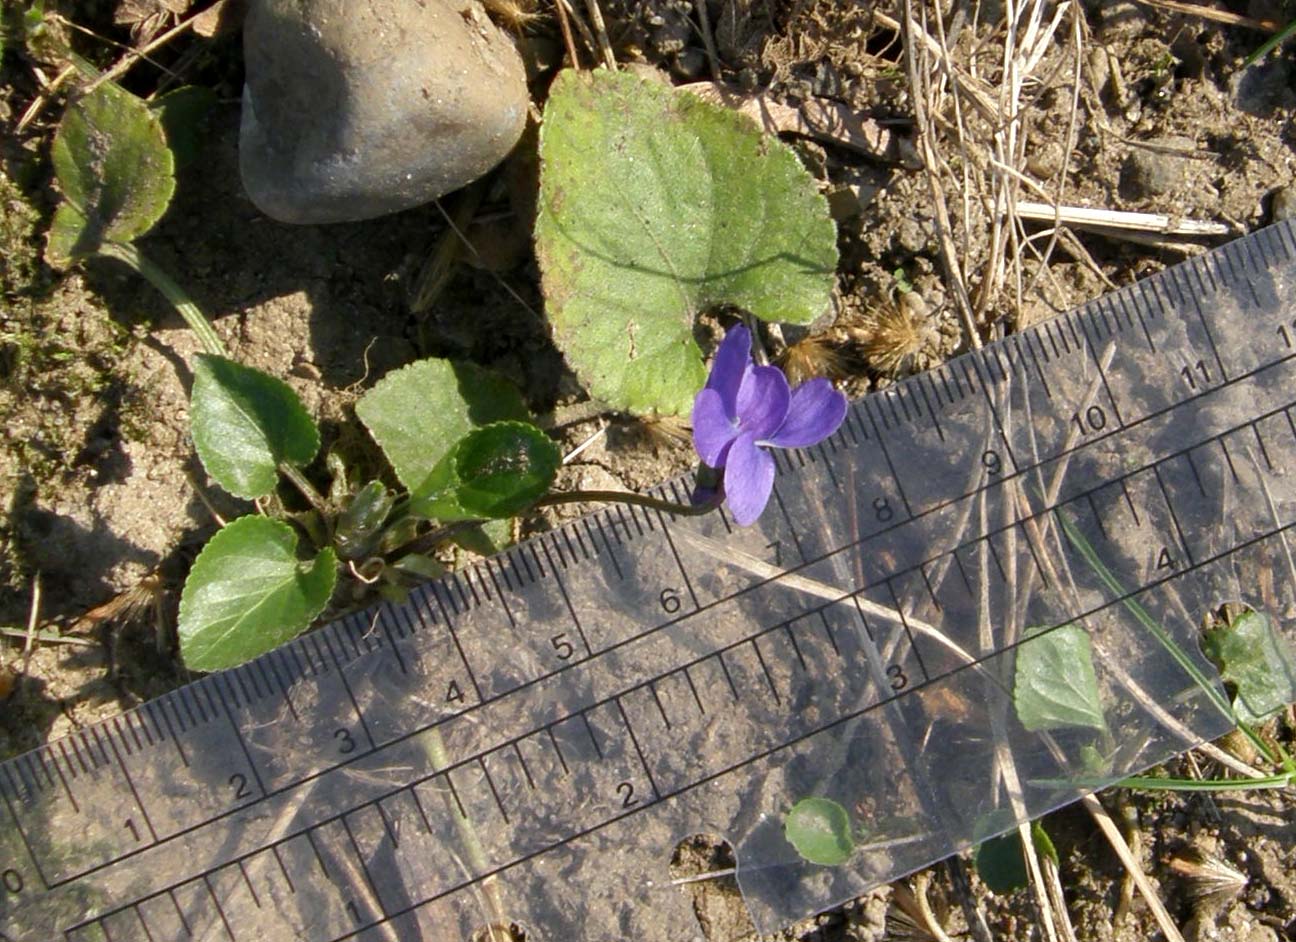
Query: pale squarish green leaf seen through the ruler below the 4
xmin=1012 ymin=625 xmax=1107 ymax=731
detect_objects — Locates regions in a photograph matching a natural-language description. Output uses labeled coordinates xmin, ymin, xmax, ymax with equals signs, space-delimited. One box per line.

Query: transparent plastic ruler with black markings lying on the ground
xmin=0 ymin=224 xmax=1296 ymax=942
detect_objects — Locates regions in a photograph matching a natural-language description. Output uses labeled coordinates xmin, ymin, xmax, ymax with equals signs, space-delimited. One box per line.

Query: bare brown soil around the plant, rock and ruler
xmin=0 ymin=0 xmax=1296 ymax=942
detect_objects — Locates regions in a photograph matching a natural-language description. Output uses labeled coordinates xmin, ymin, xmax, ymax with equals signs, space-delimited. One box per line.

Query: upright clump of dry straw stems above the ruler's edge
xmin=896 ymin=0 xmax=1083 ymax=346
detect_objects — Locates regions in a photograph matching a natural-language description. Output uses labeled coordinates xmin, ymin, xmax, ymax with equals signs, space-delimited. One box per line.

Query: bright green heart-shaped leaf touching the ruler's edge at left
xmin=179 ymin=516 xmax=337 ymax=671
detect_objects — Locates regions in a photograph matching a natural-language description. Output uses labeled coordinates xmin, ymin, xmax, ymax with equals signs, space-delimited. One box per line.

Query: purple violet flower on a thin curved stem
xmin=693 ymin=327 xmax=846 ymax=526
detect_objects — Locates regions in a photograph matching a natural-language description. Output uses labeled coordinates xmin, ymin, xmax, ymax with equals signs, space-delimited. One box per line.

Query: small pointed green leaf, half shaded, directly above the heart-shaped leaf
xmin=189 ymin=354 xmax=320 ymax=499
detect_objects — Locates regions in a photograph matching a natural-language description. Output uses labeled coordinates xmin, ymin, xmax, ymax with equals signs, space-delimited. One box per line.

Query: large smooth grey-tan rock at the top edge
xmin=238 ymin=0 xmax=529 ymax=223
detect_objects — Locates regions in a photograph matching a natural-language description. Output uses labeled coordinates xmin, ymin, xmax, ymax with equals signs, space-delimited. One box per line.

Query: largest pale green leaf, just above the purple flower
xmin=535 ymin=70 xmax=837 ymax=413
